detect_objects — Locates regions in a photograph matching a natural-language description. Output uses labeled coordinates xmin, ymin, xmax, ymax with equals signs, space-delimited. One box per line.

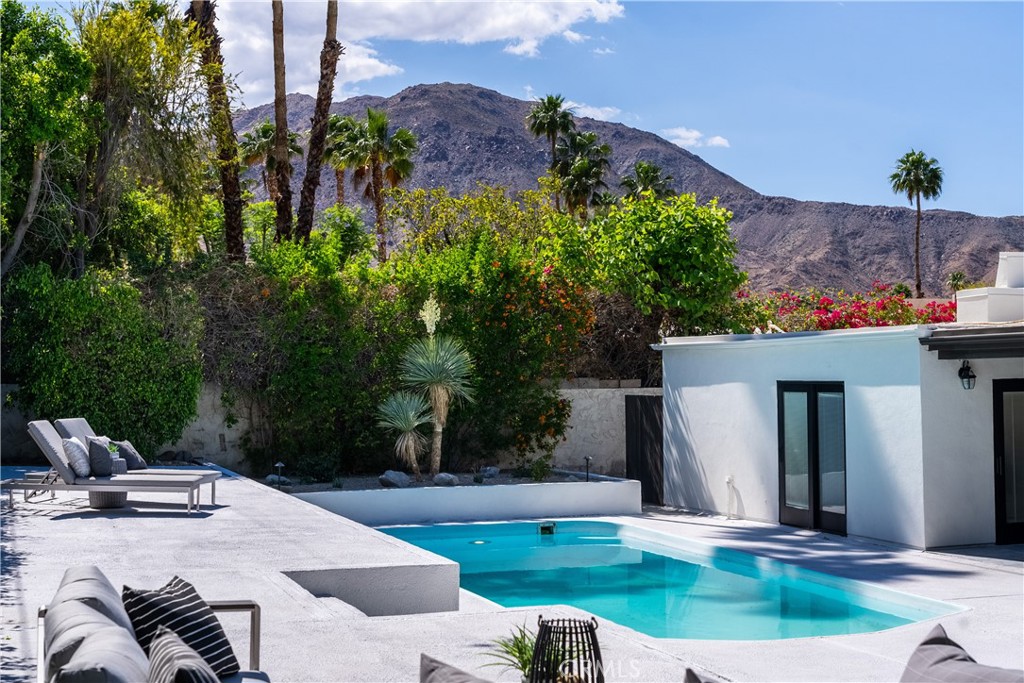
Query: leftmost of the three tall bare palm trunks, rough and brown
xmin=189 ymin=0 xmax=246 ymax=261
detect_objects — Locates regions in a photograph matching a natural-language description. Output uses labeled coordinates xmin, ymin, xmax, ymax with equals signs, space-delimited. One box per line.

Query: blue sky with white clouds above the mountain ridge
xmin=37 ymin=0 xmax=1024 ymax=216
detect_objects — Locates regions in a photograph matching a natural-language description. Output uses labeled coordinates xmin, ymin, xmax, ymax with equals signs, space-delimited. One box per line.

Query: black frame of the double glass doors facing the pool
xmin=776 ymin=381 xmax=848 ymax=536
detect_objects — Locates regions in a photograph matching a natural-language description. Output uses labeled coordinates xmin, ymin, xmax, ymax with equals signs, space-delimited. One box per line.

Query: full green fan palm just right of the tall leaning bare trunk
xmin=351 ymin=108 xmax=417 ymax=263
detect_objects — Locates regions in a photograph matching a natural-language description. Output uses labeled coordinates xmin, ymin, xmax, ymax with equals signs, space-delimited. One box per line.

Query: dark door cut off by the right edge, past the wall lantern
xmin=992 ymin=379 xmax=1024 ymax=543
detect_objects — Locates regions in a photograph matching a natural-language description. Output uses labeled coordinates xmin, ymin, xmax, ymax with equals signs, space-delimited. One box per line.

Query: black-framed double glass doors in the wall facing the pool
xmin=778 ymin=382 xmax=846 ymax=535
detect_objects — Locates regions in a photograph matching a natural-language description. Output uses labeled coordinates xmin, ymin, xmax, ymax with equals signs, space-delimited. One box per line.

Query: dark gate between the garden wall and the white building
xmin=626 ymin=395 xmax=665 ymax=505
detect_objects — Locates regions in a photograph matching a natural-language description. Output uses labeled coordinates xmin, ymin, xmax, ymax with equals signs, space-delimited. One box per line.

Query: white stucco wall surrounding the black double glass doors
xmin=659 ymin=327 xmax=933 ymax=548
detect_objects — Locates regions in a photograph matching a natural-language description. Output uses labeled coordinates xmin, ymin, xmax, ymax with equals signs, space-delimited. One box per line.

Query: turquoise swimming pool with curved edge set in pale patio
xmin=380 ymin=521 xmax=962 ymax=640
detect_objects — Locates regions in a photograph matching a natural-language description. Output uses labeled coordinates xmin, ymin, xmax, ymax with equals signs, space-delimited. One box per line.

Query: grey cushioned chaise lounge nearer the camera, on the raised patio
xmin=3 ymin=420 xmax=220 ymax=514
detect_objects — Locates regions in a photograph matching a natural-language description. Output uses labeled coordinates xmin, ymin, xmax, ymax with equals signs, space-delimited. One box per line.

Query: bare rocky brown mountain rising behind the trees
xmin=234 ymin=83 xmax=1024 ymax=295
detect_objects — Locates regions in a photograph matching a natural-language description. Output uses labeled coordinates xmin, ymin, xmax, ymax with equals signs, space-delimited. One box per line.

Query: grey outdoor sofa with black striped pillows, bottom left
xmin=36 ymin=565 xmax=270 ymax=683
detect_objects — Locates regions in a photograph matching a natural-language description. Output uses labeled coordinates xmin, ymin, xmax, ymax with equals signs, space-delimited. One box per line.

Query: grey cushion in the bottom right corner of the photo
xmin=899 ymin=624 xmax=1024 ymax=683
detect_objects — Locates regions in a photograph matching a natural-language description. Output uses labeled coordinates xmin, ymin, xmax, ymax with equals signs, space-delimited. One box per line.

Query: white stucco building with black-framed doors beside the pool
xmin=655 ymin=254 xmax=1024 ymax=548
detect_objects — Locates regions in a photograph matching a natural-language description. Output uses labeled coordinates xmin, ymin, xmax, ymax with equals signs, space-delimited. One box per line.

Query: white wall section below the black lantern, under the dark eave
xmin=921 ymin=348 xmax=1024 ymax=547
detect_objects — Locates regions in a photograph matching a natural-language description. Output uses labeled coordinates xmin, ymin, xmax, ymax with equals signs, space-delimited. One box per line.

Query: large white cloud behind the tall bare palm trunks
xmin=217 ymin=0 xmax=625 ymax=105
